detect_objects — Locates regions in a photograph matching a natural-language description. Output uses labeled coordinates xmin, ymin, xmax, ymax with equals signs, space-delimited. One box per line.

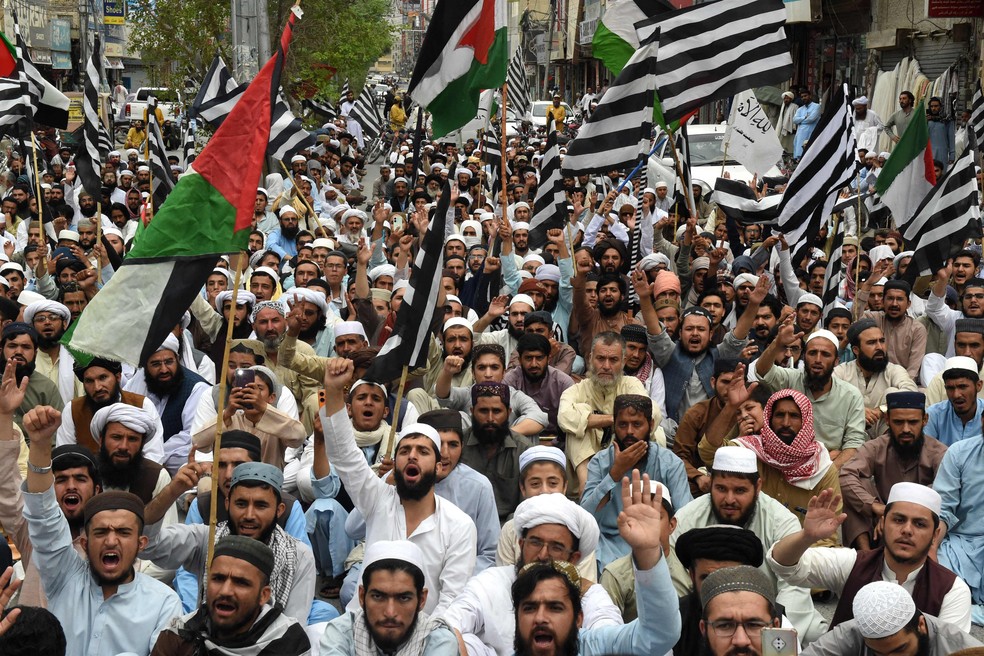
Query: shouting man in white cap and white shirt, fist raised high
xmin=320 ymin=358 xmax=477 ymax=615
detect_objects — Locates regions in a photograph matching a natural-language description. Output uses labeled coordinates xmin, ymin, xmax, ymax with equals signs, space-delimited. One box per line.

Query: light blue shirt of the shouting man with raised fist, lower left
xmin=21 ymin=483 xmax=181 ymax=656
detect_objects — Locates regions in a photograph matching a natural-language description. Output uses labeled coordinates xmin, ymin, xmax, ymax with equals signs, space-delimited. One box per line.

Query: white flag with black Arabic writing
xmin=724 ymin=90 xmax=782 ymax=175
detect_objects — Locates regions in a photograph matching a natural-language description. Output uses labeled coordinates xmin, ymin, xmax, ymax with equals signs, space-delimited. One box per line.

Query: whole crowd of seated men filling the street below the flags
xmin=0 ymin=80 xmax=984 ymax=656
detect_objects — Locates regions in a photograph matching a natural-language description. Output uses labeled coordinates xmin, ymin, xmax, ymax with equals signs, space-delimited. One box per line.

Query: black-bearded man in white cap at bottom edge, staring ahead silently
xmin=320 ymin=540 xmax=458 ymax=656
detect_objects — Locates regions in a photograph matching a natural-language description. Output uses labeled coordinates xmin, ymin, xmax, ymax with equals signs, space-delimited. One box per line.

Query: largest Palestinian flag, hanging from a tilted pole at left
xmin=62 ymin=8 xmax=299 ymax=366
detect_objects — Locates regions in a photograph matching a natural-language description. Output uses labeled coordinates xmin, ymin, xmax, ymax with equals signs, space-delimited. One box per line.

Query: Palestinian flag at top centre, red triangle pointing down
xmin=407 ymin=0 xmax=509 ymax=138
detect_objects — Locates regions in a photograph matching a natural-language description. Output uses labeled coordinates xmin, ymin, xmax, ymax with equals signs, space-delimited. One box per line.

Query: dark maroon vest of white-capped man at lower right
xmin=830 ymin=548 xmax=957 ymax=629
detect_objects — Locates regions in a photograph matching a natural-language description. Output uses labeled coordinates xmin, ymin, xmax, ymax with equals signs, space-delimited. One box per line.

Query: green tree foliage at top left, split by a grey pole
xmin=130 ymin=0 xmax=393 ymax=100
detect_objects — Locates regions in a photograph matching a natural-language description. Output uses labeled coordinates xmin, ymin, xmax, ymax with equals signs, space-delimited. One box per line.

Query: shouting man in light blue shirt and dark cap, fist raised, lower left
xmin=24 ymin=406 xmax=181 ymax=656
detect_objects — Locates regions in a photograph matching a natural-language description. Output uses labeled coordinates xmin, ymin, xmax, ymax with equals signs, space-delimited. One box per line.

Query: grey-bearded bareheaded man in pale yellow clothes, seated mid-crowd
xmin=557 ymin=331 xmax=666 ymax=490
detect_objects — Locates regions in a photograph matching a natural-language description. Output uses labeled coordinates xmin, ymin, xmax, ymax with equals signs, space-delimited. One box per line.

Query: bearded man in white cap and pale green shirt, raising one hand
xmin=756 ymin=316 xmax=867 ymax=468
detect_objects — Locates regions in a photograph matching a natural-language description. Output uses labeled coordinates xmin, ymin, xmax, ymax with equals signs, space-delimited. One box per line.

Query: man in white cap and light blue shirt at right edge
xmin=925 ymin=355 xmax=984 ymax=446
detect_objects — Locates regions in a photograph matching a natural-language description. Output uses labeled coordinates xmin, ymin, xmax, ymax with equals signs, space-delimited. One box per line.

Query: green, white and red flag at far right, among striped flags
xmin=875 ymin=101 xmax=936 ymax=231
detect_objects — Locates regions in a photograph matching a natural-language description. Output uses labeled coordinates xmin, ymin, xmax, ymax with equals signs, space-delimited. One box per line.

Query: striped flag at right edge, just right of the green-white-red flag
xmin=902 ymin=147 xmax=981 ymax=284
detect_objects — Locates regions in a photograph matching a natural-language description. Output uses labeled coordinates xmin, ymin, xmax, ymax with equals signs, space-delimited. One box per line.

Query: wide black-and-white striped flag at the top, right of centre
xmin=636 ymin=0 xmax=793 ymax=123
